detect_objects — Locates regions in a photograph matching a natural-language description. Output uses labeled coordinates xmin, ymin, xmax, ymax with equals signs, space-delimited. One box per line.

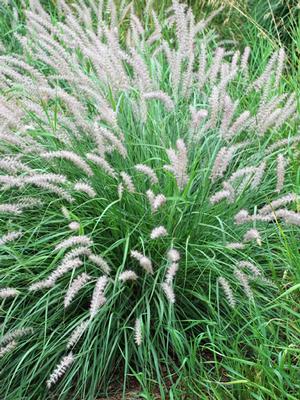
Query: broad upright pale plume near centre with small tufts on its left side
xmin=164 ymin=139 xmax=189 ymax=190
